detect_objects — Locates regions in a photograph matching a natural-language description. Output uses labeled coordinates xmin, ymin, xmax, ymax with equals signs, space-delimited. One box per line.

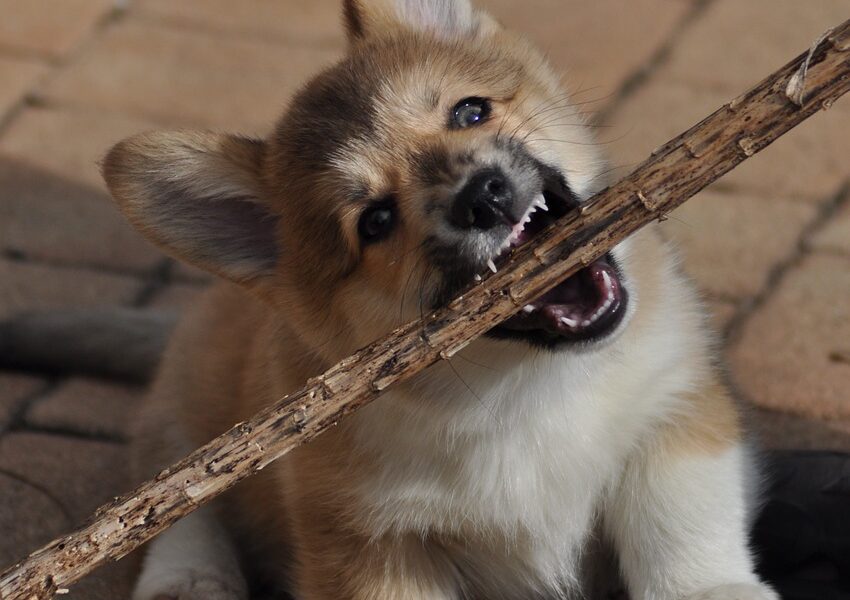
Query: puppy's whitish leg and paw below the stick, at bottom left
xmin=133 ymin=508 xmax=248 ymax=600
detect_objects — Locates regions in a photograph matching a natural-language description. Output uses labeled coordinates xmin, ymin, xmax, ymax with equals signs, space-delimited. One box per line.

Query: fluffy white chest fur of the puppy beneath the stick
xmin=344 ymin=310 xmax=693 ymax=583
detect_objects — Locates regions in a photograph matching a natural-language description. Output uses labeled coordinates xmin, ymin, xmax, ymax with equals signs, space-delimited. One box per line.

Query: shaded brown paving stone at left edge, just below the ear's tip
xmin=0 ymin=151 xmax=162 ymax=272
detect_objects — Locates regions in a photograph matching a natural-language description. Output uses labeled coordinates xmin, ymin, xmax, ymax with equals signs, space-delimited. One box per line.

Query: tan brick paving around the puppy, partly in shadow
xmin=0 ymin=0 xmax=850 ymax=600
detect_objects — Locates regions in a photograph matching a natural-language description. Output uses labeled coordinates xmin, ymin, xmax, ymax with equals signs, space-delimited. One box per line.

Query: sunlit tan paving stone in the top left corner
xmin=0 ymin=0 xmax=115 ymax=58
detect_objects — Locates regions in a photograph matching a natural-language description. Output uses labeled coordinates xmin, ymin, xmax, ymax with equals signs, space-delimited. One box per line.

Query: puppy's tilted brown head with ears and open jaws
xmin=105 ymin=0 xmax=627 ymax=358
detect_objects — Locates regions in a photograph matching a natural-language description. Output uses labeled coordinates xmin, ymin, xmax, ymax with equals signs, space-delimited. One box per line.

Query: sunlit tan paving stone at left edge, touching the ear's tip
xmin=0 ymin=107 xmax=156 ymax=192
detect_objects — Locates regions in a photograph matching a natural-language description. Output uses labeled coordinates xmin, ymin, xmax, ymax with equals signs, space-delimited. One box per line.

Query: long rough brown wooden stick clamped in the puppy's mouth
xmin=0 ymin=21 xmax=850 ymax=600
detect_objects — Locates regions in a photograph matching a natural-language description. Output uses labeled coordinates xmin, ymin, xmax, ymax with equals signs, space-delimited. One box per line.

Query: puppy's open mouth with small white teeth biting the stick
xmin=488 ymin=173 xmax=628 ymax=346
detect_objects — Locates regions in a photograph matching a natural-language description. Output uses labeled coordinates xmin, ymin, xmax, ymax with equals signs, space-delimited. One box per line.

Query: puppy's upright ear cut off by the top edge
xmin=343 ymin=0 xmax=497 ymax=42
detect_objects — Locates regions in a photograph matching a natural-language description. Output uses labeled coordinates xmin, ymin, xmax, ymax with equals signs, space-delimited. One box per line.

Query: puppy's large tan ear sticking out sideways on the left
xmin=103 ymin=131 xmax=278 ymax=285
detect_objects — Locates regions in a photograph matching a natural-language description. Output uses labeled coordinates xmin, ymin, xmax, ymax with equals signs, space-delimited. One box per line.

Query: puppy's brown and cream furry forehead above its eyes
xmin=275 ymin=37 xmax=522 ymax=170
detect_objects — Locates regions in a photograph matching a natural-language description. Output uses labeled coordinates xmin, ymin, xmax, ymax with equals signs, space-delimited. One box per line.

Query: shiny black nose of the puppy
xmin=450 ymin=169 xmax=515 ymax=229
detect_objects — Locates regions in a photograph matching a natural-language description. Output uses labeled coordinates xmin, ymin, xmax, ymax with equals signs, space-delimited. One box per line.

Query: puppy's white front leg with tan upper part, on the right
xmin=605 ymin=385 xmax=778 ymax=600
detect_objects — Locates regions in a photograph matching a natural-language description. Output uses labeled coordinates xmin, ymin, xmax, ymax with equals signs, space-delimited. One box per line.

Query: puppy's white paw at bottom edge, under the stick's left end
xmin=133 ymin=571 xmax=248 ymax=600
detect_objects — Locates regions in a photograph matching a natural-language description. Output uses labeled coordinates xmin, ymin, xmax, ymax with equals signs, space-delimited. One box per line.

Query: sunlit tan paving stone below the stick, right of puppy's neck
xmin=663 ymin=191 xmax=816 ymax=298
